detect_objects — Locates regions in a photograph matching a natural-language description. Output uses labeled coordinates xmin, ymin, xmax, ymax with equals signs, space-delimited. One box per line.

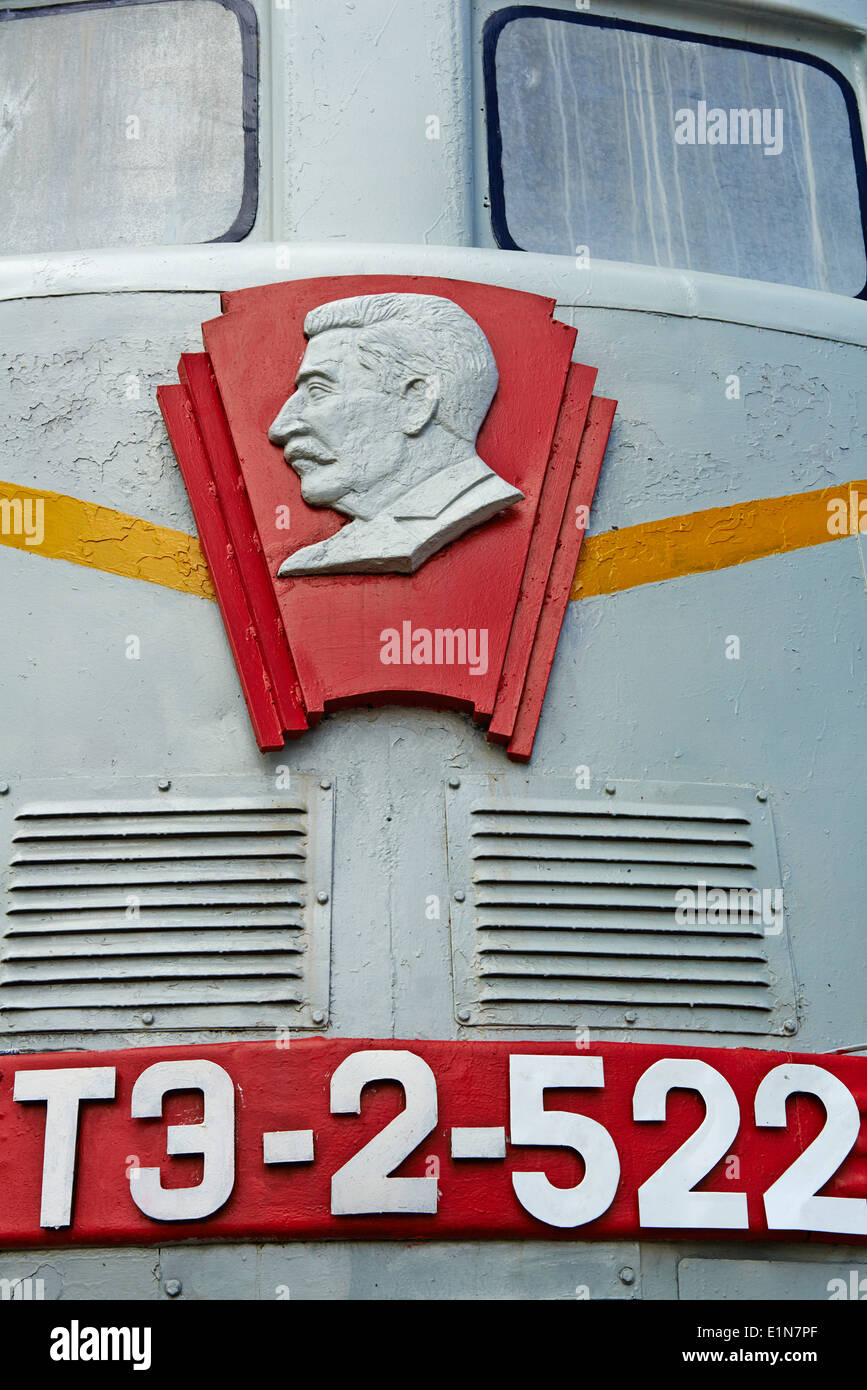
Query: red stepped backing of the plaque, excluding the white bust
xmin=157 ymin=275 xmax=616 ymax=760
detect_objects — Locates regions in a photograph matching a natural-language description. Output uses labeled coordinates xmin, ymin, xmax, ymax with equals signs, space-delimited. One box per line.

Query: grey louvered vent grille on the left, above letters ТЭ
xmin=0 ymin=776 xmax=332 ymax=1034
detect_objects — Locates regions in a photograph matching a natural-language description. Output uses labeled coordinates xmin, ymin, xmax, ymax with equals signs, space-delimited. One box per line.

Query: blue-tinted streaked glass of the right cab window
xmin=492 ymin=15 xmax=867 ymax=295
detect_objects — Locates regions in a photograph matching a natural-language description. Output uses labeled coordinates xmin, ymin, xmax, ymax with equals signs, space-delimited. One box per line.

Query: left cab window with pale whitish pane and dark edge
xmin=0 ymin=0 xmax=258 ymax=256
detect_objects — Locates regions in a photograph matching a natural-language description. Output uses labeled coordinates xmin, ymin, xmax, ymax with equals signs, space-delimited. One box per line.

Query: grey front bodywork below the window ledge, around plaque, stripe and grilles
xmin=3 ymin=271 xmax=864 ymax=1049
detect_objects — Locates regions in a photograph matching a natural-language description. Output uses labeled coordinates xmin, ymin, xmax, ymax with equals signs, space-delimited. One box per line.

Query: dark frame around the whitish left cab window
xmin=0 ymin=0 xmax=258 ymax=246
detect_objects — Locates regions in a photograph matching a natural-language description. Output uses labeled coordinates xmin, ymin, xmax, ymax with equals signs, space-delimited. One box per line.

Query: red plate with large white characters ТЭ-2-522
xmin=0 ymin=1037 xmax=867 ymax=1247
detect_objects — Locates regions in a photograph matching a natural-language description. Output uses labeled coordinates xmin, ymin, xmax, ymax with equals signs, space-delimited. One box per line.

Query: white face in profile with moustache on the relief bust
xmin=268 ymin=328 xmax=407 ymax=517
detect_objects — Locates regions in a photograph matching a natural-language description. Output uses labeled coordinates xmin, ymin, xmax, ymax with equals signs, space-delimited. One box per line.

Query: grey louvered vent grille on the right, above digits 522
xmin=446 ymin=777 xmax=795 ymax=1033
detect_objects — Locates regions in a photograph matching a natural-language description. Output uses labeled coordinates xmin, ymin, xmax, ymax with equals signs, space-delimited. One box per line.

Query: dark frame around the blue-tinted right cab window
xmin=482 ymin=4 xmax=867 ymax=299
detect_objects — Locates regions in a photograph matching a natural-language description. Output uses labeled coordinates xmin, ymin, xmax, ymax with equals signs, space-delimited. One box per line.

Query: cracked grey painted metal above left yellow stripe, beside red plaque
xmin=0 ymin=293 xmax=220 ymax=530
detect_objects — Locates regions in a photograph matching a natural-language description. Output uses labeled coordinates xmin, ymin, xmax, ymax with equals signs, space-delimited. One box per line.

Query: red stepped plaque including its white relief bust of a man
xmin=158 ymin=275 xmax=616 ymax=760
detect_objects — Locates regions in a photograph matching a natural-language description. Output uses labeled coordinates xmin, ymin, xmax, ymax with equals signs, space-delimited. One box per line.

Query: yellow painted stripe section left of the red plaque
xmin=0 ymin=482 xmax=215 ymax=599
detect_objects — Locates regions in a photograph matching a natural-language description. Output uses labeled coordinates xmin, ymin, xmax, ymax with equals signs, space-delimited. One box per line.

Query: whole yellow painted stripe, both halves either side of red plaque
xmin=0 ymin=480 xmax=867 ymax=599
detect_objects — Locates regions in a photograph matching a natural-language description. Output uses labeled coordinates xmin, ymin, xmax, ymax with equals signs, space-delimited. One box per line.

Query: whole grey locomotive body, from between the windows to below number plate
xmin=0 ymin=0 xmax=867 ymax=1298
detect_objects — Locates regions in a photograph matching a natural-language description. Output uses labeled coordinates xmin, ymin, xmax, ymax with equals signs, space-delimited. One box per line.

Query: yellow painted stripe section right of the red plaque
xmin=571 ymin=480 xmax=867 ymax=599
